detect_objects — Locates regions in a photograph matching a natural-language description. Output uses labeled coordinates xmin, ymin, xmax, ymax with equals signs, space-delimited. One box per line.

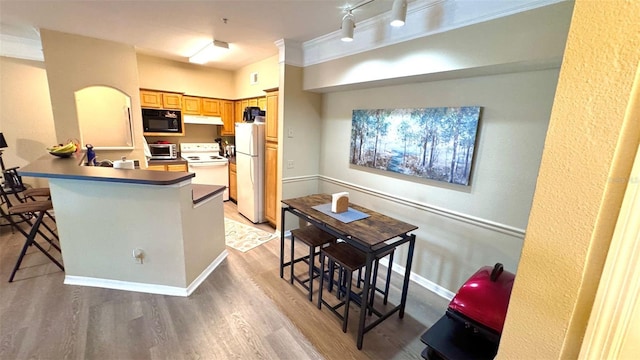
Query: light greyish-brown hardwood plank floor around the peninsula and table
xmin=0 ymin=201 xmax=447 ymax=359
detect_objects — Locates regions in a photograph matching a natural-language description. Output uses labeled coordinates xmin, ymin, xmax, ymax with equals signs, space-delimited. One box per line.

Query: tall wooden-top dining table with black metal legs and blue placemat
xmin=280 ymin=194 xmax=418 ymax=349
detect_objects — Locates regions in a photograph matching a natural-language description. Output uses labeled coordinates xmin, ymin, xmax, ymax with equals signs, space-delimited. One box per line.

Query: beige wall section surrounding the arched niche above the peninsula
xmin=40 ymin=29 xmax=144 ymax=163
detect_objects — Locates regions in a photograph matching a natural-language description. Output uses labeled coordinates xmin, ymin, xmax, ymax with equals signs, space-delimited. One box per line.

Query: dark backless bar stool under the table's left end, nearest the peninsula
xmin=290 ymin=225 xmax=336 ymax=301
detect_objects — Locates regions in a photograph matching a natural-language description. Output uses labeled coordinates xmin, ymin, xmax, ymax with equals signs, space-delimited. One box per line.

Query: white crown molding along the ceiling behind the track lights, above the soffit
xmin=302 ymin=0 xmax=567 ymax=66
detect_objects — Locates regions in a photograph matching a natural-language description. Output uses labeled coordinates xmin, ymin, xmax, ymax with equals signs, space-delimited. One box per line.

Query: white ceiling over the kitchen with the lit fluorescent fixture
xmin=0 ymin=0 xmax=400 ymax=70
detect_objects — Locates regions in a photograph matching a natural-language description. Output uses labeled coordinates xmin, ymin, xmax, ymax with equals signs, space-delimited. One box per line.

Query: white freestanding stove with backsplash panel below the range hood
xmin=180 ymin=143 xmax=229 ymax=201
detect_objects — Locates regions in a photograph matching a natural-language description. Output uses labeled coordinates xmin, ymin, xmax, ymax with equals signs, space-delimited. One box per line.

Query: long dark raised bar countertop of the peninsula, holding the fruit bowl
xmin=18 ymin=154 xmax=195 ymax=185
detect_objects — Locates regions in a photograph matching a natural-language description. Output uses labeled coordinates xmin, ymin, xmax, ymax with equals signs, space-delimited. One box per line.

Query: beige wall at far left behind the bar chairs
xmin=0 ymin=57 xmax=57 ymax=186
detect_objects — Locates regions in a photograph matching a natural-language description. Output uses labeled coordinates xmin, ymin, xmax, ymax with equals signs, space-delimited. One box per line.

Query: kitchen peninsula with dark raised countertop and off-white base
xmin=19 ymin=155 xmax=227 ymax=296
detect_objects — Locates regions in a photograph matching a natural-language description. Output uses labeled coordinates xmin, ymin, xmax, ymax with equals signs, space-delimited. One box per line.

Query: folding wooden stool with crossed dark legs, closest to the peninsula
xmin=9 ymin=200 xmax=64 ymax=282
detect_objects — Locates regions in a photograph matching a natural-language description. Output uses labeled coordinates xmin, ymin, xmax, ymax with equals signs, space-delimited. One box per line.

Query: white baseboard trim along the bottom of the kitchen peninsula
xmin=64 ymin=249 xmax=229 ymax=297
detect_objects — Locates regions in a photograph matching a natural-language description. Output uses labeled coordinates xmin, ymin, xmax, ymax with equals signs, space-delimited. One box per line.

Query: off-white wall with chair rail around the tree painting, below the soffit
xmin=320 ymin=70 xmax=558 ymax=292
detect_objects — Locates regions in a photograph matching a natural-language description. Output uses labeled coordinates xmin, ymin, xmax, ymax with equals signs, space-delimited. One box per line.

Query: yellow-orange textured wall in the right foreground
xmin=498 ymin=0 xmax=640 ymax=359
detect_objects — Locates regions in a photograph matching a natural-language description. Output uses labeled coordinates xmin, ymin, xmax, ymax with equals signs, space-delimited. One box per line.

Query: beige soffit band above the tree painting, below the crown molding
xmin=303 ymin=1 xmax=573 ymax=91
